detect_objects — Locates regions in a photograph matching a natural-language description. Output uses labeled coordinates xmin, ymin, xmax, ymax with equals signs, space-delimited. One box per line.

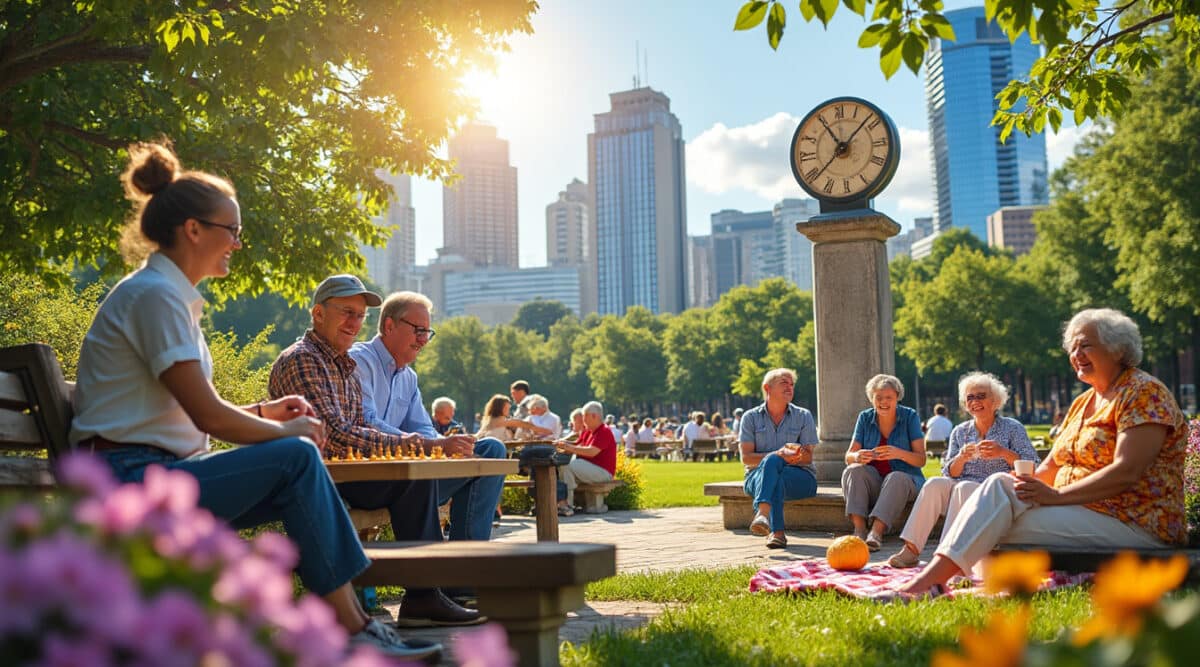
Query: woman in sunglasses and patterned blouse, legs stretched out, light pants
xmin=888 ymin=372 xmax=1038 ymax=567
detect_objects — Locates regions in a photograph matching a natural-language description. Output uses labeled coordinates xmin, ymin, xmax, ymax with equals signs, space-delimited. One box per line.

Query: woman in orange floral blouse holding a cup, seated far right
xmin=899 ymin=308 xmax=1188 ymax=594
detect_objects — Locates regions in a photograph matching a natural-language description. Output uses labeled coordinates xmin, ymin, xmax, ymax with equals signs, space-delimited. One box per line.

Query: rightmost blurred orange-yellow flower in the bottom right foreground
xmin=1073 ymin=552 xmax=1188 ymax=647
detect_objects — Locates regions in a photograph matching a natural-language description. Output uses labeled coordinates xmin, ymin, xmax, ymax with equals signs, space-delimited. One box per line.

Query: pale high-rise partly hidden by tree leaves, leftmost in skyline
xmin=360 ymin=169 xmax=420 ymax=292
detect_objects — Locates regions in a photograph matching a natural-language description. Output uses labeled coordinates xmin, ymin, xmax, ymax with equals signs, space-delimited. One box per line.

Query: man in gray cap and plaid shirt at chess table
xmin=269 ymin=274 xmax=486 ymax=626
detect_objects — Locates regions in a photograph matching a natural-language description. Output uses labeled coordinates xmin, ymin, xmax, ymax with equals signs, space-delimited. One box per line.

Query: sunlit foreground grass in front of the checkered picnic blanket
xmin=571 ymin=567 xmax=1091 ymax=667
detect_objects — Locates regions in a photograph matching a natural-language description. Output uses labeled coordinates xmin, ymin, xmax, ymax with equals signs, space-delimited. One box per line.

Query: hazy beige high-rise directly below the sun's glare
xmin=442 ymin=124 xmax=520 ymax=269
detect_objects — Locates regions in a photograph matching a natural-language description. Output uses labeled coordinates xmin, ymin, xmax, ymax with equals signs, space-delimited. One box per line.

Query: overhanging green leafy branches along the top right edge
xmin=733 ymin=0 xmax=1200 ymax=138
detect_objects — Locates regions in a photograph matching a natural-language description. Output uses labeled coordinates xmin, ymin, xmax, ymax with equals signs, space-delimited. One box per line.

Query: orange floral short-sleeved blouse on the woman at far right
xmin=1050 ymin=368 xmax=1188 ymax=545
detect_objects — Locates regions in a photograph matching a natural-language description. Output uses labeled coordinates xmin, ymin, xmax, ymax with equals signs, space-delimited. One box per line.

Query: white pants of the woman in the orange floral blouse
xmin=937 ymin=473 xmax=1168 ymax=572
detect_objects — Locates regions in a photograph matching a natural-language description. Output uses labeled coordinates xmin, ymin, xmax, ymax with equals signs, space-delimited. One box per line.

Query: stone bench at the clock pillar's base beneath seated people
xmin=704 ymin=481 xmax=916 ymax=535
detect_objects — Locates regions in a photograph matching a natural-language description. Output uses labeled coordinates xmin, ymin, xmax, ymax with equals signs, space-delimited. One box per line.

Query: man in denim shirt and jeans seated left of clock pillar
xmin=738 ymin=368 xmax=818 ymax=549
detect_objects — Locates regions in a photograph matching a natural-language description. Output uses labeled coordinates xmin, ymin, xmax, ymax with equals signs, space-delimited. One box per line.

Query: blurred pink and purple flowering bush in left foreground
xmin=0 ymin=453 xmax=386 ymax=667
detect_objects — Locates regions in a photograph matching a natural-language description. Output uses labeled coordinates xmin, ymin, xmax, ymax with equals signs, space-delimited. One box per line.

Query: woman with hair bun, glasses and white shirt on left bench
xmin=71 ymin=144 xmax=440 ymax=659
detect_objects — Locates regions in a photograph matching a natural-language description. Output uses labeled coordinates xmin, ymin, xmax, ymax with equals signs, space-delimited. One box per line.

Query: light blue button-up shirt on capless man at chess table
xmin=350 ymin=335 xmax=438 ymax=438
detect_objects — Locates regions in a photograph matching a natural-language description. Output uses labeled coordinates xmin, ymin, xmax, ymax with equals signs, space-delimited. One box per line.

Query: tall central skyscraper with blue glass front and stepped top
xmin=588 ymin=88 xmax=688 ymax=314
